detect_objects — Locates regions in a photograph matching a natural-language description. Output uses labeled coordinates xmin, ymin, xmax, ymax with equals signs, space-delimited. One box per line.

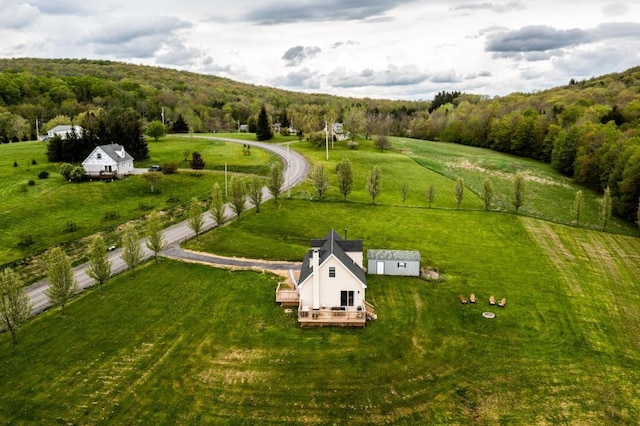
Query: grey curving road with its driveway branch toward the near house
xmin=26 ymin=136 xmax=309 ymax=315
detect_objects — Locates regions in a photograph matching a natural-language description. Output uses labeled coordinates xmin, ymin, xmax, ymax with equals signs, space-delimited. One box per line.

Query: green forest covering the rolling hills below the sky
xmin=0 ymin=58 xmax=640 ymax=221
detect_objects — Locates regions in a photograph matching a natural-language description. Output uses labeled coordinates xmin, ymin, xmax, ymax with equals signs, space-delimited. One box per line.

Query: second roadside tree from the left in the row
xmin=45 ymin=247 xmax=78 ymax=316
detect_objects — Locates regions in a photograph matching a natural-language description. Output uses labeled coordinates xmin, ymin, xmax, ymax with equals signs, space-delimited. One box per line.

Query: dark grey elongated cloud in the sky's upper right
xmin=486 ymin=25 xmax=593 ymax=52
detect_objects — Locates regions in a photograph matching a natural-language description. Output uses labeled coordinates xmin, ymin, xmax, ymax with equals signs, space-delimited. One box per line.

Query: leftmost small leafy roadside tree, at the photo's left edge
xmin=0 ymin=268 xmax=32 ymax=345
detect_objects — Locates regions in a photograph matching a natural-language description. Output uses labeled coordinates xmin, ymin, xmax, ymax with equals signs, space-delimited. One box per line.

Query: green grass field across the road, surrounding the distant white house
xmin=0 ymin=138 xmax=273 ymax=265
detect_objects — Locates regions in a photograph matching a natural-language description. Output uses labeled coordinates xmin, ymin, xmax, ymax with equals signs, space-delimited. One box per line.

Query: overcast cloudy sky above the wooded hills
xmin=0 ymin=0 xmax=640 ymax=100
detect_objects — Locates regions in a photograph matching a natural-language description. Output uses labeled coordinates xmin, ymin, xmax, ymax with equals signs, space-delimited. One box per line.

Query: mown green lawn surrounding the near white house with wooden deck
xmin=0 ymin=210 xmax=640 ymax=424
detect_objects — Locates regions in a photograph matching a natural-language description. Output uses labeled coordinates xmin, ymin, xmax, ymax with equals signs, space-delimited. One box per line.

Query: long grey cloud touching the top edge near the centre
xmin=244 ymin=0 xmax=415 ymax=25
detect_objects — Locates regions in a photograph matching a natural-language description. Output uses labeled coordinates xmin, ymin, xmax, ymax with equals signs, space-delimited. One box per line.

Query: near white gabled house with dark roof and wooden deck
xmin=297 ymin=230 xmax=375 ymax=327
